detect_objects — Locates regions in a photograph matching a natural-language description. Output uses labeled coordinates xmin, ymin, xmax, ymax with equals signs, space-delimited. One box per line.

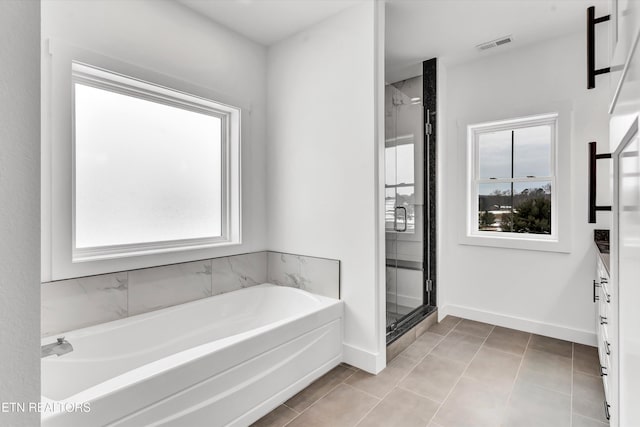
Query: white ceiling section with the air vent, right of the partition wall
xmin=385 ymin=0 xmax=609 ymax=82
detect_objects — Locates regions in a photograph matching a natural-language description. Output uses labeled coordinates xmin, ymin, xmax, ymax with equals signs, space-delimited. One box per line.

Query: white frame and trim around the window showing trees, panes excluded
xmin=460 ymin=113 xmax=571 ymax=253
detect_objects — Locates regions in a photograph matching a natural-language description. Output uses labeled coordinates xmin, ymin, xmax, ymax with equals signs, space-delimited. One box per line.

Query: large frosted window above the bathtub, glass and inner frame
xmin=72 ymin=62 xmax=240 ymax=262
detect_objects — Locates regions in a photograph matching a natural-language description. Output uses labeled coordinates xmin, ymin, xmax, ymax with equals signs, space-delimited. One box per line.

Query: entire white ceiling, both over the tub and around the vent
xmin=177 ymin=0 xmax=611 ymax=82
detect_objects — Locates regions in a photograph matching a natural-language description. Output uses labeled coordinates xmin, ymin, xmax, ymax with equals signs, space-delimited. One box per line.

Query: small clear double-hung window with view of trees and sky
xmin=468 ymin=114 xmax=557 ymax=240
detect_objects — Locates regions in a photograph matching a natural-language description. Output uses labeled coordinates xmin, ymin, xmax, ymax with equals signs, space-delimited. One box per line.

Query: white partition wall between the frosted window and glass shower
xmin=267 ymin=2 xmax=384 ymax=371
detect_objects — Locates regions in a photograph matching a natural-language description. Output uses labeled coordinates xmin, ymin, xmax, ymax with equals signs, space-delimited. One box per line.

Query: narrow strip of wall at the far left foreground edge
xmin=0 ymin=0 xmax=40 ymax=426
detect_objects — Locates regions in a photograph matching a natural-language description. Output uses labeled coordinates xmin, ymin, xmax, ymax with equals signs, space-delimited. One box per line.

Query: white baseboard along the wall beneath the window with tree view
xmin=438 ymin=305 xmax=597 ymax=346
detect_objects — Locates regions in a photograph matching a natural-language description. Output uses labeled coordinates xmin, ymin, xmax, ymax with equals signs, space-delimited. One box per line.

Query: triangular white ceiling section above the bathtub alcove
xmin=178 ymin=0 xmax=364 ymax=46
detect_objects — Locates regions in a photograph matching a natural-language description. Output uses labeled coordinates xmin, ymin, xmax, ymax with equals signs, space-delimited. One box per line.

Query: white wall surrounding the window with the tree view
xmin=438 ymin=34 xmax=608 ymax=343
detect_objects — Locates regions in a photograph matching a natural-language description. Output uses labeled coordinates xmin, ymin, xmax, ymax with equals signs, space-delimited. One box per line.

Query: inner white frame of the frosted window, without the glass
xmin=71 ymin=61 xmax=240 ymax=263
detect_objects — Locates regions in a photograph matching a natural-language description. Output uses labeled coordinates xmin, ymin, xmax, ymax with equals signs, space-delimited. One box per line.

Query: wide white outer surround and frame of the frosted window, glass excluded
xmin=41 ymin=39 xmax=242 ymax=283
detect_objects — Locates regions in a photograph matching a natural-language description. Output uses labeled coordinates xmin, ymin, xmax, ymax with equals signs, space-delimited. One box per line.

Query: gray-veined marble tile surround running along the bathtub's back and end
xmin=41 ymin=251 xmax=340 ymax=337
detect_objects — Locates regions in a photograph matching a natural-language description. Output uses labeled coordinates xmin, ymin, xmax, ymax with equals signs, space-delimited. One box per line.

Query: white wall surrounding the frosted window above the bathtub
xmin=42 ymin=0 xmax=267 ymax=281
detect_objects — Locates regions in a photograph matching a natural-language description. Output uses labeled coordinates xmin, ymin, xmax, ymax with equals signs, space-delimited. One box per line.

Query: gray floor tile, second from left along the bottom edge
xmin=287 ymin=384 xmax=380 ymax=427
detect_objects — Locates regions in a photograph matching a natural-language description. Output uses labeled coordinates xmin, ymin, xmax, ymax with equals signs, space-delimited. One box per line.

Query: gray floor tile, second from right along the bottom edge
xmin=502 ymin=382 xmax=571 ymax=427
